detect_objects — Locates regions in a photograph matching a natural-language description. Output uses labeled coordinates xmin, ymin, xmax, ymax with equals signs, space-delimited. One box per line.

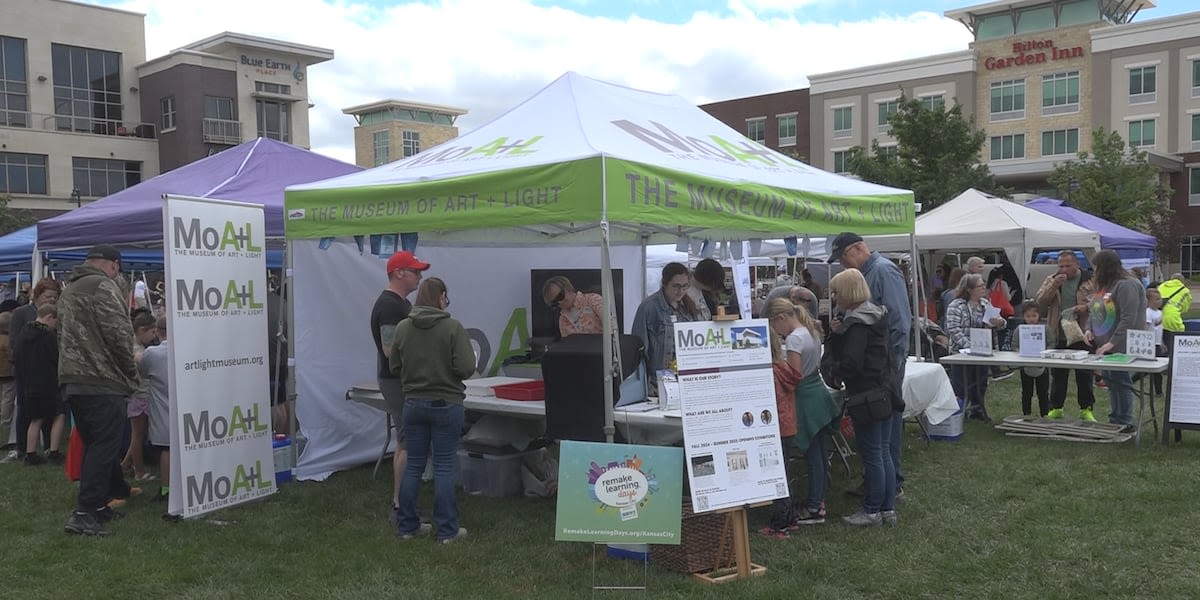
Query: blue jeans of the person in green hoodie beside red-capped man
xmin=396 ymin=398 xmax=463 ymax=540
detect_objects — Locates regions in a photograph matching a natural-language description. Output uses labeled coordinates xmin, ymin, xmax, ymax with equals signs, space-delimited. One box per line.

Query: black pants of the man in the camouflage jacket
xmin=67 ymin=394 xmax=130 ymax=512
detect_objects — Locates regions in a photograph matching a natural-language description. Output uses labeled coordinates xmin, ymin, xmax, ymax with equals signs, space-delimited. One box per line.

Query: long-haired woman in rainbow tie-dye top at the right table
xmin=1085 ymin=250 xmax=1146 ymax=427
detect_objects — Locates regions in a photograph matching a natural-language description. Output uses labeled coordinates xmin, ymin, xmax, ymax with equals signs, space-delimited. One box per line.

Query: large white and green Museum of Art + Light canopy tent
xmin=284 ymin=73 xmax=914 ymax=476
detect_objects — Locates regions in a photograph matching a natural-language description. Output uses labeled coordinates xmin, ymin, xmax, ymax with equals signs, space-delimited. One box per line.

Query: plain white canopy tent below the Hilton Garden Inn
xmin=869 ymin=188 xmax=1100 ymax=288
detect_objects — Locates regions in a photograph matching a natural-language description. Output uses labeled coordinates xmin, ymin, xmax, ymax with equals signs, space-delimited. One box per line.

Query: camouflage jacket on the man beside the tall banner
xmin=59 ymin=264 xmax=138 ymax=395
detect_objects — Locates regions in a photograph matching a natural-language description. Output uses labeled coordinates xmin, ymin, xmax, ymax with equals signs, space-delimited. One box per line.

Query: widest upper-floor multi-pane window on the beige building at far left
xmin=50 ymin=43 xmax=124 ymax=136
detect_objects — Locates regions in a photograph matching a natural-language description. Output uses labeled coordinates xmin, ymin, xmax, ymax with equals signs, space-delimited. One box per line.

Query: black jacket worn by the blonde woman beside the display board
xmin=821 ymin=302 xmax=904 ymax=410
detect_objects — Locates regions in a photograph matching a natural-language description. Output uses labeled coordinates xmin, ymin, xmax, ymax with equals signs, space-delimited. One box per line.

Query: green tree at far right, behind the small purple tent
xmin=1049 ymin=127 xmax=1171 ymax=230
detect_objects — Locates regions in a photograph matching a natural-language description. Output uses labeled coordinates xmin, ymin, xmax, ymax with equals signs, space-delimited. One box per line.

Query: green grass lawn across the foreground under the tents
xmin=0 ymin=377 xmax=1200 ymax=599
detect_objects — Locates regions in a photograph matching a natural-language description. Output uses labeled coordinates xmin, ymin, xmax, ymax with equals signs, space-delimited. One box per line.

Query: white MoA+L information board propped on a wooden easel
xmin=676 ymin=319 xmax=787 ymax=512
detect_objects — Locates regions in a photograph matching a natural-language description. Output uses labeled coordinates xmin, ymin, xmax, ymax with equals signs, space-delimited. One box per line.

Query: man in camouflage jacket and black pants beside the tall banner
xmin=59 ymin=245 xmax=138 ymax=535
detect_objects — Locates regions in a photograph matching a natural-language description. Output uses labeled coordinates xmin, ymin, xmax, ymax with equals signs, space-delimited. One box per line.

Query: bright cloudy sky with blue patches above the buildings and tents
xmin=83 ymin=0 xmax=1196 ymax=162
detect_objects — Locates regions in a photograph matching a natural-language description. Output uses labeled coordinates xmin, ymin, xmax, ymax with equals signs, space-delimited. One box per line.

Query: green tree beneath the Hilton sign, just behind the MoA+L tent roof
xmin=848 ymin=96 xmax=1008 ymax=210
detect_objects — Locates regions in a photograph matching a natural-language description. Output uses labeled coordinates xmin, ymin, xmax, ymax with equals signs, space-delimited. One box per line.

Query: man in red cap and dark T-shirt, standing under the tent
xmin=371 ymin=250 xmax=430 ymax=511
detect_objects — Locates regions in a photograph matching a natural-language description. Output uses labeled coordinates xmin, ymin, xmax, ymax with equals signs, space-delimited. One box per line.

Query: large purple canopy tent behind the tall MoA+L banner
xmin=37 ymin=138 xmax=362 ymax=252
